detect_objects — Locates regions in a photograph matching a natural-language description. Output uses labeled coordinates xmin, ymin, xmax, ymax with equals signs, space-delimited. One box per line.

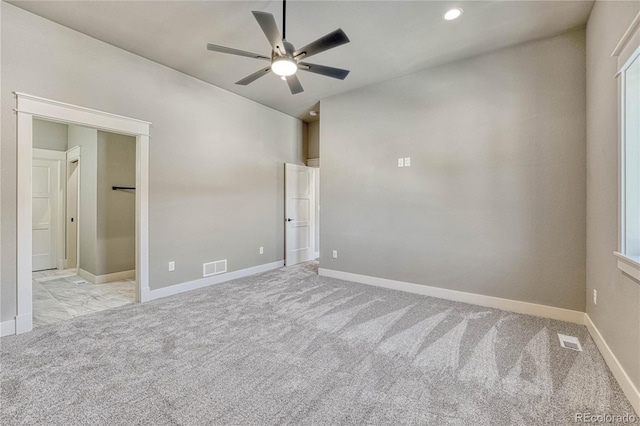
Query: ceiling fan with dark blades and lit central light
xmin=207 ymin=0 xmax=349 ymax=95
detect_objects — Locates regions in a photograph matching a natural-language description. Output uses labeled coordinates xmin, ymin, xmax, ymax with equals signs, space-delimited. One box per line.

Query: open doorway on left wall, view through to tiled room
xmin=32 ymin=119 xmax=136 ymax=327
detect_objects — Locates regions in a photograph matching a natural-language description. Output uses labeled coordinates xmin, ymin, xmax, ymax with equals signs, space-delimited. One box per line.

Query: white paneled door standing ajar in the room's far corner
xmin=284 ymin=164 xmax=315 ymax=266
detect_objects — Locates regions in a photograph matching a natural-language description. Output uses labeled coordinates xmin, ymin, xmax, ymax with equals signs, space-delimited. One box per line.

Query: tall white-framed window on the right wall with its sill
xmin=616 ymin=35 xmax=640 ymax=280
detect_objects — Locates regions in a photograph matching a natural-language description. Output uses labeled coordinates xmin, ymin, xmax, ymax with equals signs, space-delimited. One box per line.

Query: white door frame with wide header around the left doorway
xmin=14 ymin=92 xmax=151 ymax=334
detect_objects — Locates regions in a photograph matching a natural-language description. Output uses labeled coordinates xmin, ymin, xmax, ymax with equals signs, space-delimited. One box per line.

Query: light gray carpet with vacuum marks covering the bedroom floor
xmin=0 ymin=263 xmax=633 ymax=425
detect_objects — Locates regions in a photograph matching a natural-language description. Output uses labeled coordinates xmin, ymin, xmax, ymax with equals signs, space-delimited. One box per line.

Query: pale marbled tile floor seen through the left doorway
xmin=32 ymin=269 xmax=136 ymax=327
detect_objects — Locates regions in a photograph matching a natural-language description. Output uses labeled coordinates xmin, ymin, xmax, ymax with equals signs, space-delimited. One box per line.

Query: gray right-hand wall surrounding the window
xmin=587 ymin=1 xmax=640 ymax=388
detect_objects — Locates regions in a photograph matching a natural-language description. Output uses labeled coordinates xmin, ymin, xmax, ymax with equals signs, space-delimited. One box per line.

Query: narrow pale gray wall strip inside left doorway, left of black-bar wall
xmin=68 ymin=124 xmax=98 ymax=275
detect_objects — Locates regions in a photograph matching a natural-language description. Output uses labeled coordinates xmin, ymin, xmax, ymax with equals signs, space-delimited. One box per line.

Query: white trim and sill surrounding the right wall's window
xmin=613 ymin=43 xmax=640 ymax=281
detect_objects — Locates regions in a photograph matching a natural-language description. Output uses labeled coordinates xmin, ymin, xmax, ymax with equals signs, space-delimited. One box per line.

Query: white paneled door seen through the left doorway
xmin=31 ymin=158 xmax=60 ymax=271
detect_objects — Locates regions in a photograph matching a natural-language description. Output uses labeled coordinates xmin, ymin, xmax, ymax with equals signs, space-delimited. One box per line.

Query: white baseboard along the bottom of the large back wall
xmin=318 ymin=268 xmax=584 ymax=324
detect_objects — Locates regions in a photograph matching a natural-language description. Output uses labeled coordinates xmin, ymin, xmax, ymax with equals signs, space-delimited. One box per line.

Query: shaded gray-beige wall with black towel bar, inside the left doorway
xmin=96 ymin=131 xmax=136 ymax=275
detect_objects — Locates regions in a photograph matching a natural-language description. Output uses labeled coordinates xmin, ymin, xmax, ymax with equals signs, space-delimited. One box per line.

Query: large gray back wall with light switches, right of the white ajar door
xmin=320 ymin=30 xmax=586 ymax=311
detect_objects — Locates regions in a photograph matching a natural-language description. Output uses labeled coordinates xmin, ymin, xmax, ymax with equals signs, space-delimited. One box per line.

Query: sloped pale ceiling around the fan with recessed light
xmin=10 ymin=0 xmax=593 ymax=121
